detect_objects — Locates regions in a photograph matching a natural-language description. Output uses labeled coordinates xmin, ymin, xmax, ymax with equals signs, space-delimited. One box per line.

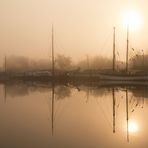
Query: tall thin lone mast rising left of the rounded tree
xmin=51 ymin=24 xmax=55 ymax=78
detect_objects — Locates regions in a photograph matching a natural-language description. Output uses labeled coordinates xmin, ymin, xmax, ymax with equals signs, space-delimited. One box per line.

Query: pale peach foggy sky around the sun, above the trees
xmin=0 ymin=0 xmax=148 ymax=66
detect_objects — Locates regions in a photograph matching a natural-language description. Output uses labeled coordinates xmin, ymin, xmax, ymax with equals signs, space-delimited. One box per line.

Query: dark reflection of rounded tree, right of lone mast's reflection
xmin=55 ymin=86 xmax=71 ymax=99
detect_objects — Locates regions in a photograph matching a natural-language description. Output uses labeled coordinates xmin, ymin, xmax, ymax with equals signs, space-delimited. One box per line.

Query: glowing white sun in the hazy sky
xmin=122 ymin=10 xmax=142 ymax=31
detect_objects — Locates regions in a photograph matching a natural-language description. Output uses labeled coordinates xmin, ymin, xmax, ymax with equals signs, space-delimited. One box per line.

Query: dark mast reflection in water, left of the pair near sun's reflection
xmin=112 ymin=88 xmax=116 ymax=133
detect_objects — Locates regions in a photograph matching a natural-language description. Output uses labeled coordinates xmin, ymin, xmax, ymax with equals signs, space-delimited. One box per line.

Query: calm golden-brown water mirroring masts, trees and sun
xmin=0 ymin=84 xmax=148 ymax=148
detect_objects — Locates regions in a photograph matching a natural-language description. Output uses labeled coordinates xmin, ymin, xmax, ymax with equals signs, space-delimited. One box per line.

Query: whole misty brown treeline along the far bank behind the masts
xmin=3 ymin=54 xmax=148 ymax=72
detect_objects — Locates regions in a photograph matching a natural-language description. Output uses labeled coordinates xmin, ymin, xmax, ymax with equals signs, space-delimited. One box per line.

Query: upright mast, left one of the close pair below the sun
xmin=113 ymin=27 xmax=116 ymax=71
